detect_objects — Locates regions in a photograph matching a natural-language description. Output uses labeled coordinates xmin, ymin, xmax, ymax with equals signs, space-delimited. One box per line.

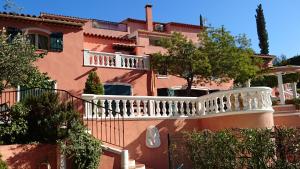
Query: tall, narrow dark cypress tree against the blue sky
xmin=255 ymin=4 xmax=269 ymax=55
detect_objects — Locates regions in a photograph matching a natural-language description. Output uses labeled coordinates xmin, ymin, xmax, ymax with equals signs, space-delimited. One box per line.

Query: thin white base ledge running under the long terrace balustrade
xmin=83 ymin=109 xmax=274 ymax=121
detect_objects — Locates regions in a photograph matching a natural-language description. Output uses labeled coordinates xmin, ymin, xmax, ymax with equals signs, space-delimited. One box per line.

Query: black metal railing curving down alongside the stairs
xmin=0 ymin=88 xmax=124 ymax=147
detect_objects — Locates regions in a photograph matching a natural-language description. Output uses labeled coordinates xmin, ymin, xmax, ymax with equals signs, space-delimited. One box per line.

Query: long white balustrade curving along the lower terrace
xmin=82 ymin=87 xmax=273 ymax=118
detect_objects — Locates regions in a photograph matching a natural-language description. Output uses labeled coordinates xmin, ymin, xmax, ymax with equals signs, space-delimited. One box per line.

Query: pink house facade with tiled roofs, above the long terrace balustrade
xmin=0 ymin=5 xmax=251 ymax=96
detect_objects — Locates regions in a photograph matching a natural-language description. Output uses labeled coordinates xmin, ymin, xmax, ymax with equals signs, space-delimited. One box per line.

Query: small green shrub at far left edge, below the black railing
xmin=0 ymin=103 xmax=29 ymax=144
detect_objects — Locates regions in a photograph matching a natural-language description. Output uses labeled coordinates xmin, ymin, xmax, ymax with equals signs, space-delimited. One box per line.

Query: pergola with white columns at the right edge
xmin=265 ymin=65 xmax=300 ymax=104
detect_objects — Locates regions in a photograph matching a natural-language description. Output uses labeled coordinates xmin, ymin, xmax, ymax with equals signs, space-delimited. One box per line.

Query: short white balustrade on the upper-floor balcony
xmin=83 ymin=50 xmax=149 ymax=70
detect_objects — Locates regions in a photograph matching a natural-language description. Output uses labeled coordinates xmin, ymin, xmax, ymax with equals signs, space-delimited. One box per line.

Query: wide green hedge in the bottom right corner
xmin=184 ymin=127 xmax=300 ymax=169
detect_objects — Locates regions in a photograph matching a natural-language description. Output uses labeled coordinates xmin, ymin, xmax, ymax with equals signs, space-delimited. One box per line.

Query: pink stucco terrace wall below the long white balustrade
xmin=87 ymin=112 xmax=274 ymax=169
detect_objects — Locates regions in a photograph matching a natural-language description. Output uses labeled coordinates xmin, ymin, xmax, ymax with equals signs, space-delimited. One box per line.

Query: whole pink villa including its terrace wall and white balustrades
xmin=0 ymin=5 xmax=299 ymax=169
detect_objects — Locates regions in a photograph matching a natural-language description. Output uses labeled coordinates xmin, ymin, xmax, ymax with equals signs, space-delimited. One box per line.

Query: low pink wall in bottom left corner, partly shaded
xmin=6 ymin=144 xmax=57 ymax=169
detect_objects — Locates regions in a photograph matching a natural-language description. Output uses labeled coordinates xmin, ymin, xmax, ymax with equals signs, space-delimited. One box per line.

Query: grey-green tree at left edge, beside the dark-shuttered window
xmin=0 ymin=29 xmax=53 ymax=89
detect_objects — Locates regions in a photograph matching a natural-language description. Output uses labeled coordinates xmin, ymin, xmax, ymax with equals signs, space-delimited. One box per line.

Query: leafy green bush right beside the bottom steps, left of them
xmin=60 ymin=122 xmax=102 ymax=169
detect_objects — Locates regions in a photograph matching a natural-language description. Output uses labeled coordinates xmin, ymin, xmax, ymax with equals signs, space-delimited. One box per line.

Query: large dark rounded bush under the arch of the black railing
xmin=24 ymin=92 xmax=78 ymax=143
